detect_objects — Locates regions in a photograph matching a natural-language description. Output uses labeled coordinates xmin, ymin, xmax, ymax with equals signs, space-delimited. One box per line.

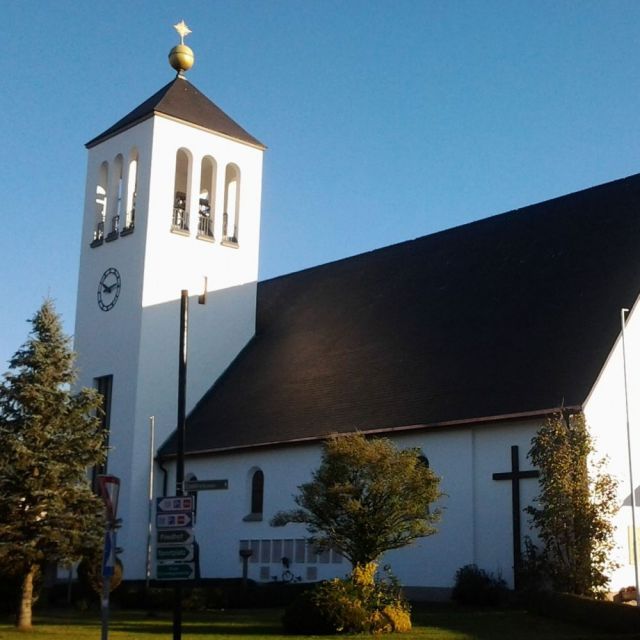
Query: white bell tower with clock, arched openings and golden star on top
xmin=75 ymin=22 xmax=265 ymax=579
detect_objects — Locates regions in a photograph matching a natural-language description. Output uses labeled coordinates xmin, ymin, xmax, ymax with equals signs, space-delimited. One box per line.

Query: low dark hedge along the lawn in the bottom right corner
xmin=523 ymin=591 xmax=640 ymax=638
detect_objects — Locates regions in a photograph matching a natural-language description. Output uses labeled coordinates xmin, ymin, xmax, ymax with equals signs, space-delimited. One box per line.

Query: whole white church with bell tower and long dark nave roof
xmin=75 ymin=33 xmax=640 ymax=589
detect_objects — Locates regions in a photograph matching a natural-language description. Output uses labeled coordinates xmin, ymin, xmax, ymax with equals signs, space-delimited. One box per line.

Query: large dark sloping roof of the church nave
xmin=160 ymin=175 xmax=640 ymax=455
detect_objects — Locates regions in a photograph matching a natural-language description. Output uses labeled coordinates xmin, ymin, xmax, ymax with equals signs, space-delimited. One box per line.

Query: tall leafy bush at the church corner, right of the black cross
xmin=527 ymin=412 xmax=618 ymax=596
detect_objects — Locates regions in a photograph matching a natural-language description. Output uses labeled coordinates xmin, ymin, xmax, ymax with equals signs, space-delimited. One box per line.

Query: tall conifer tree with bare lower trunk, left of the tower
xmin=0 ymin=300 xmax=105 ymax=629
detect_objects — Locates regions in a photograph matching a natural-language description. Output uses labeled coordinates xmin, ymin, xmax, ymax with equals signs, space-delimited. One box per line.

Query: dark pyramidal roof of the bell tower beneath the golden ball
xmin=86 ymin=75 xmax=264 ymax=149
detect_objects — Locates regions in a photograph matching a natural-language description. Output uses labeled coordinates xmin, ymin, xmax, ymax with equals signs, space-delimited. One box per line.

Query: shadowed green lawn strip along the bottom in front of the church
xmin=0 ymin=606 xmax=640 ymax=640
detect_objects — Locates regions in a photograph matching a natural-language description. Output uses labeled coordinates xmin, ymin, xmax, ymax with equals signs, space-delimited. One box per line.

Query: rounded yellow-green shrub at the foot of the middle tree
xmin=282 ymin=563 xmax=411 ymax=634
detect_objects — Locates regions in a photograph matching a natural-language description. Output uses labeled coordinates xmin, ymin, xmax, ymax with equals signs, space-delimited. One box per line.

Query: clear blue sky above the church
xmin=0 ymin=0 xmax=640 ymax=371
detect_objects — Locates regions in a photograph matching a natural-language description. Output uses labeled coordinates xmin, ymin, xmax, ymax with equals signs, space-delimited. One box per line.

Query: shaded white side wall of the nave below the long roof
xmin=175 ymin=421 xmax=538 ymax=588
